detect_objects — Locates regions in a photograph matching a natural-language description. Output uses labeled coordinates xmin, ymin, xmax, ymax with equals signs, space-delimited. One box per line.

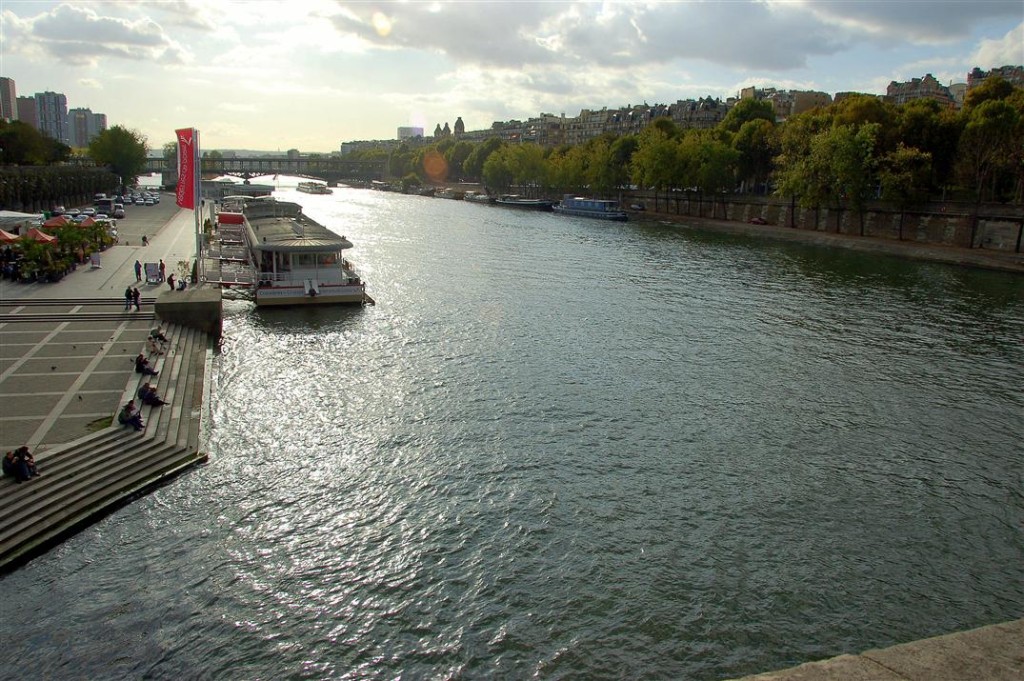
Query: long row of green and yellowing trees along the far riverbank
xmin=346 ymin=78 xmax=1024 ymax=209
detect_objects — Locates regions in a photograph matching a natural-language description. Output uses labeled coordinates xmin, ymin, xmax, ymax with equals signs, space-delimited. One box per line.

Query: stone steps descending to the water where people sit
xmin=0 ymin=315 xmax=210 ymax=568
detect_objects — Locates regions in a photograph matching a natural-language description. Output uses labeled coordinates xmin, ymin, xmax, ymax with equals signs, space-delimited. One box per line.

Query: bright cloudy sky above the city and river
xmin=0 ymin=0 xmax=1024 ymax=152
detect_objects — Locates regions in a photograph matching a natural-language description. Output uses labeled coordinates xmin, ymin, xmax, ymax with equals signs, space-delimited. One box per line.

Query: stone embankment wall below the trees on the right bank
xmin=622 ymin=193 xmax=1024 ymax=253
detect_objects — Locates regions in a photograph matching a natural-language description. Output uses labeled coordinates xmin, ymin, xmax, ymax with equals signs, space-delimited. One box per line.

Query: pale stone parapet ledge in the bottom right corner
xmin=737 ymin=620 xmax=1024 ymax=681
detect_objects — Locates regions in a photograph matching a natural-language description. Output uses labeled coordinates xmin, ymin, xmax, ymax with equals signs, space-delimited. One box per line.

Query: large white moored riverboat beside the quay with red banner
xmin=218 ymin=197 xmax=373 ymax=306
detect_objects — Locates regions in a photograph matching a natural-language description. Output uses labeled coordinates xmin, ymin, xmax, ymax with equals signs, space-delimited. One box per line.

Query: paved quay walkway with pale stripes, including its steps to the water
xmin=0 ymin=195 xmax=213 ymax=571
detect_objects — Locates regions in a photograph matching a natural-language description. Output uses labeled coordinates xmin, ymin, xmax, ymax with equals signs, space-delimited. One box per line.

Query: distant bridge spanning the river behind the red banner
xmin=145 ymin=156 xmax=386 ymax=185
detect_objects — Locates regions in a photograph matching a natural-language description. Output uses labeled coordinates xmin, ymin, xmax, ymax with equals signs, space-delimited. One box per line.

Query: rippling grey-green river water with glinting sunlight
xmin=0 ymin=183 xmax=1024 ymax=679
